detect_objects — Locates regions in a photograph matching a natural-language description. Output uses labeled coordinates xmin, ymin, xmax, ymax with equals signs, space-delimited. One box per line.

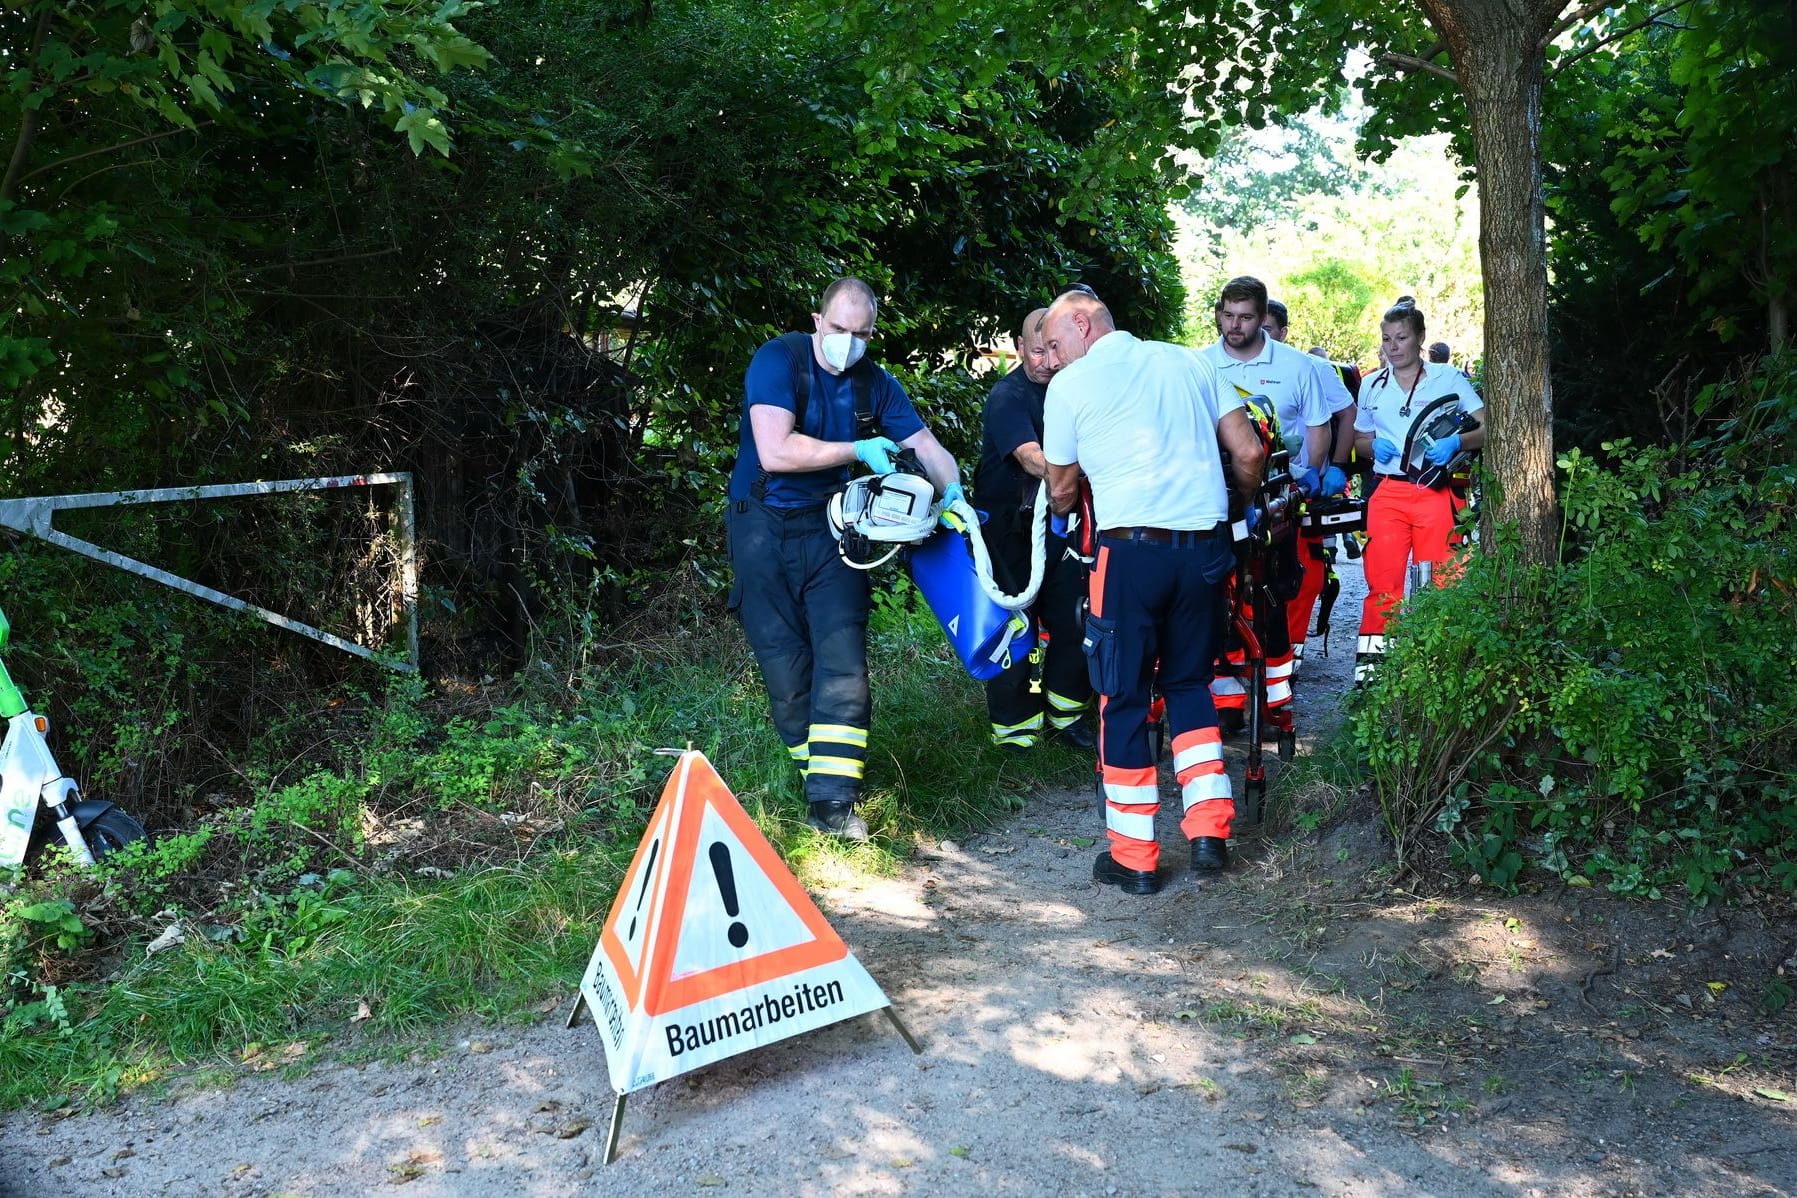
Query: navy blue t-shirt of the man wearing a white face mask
xmin=730 ymin=338 xmax=924 ymax=508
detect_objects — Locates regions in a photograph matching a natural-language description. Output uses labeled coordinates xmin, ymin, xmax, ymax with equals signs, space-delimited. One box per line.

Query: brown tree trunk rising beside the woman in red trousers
xmin=1420 ymin=0 xmax=1565 ymax=562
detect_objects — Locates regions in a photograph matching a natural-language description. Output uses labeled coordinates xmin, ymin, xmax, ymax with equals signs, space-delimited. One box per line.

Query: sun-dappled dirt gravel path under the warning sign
xmin=0 ymin=569 xmax=1797 ymax=1198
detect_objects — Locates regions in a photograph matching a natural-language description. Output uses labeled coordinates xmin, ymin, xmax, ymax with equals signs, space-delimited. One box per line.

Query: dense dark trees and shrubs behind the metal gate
xmin=0 ymin=0 xmax=1182 ymax=826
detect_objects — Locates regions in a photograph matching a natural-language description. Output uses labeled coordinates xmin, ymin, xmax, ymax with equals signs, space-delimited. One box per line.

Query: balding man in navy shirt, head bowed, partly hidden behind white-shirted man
xmin=974 ymin=307 xmax=1098 ymax=751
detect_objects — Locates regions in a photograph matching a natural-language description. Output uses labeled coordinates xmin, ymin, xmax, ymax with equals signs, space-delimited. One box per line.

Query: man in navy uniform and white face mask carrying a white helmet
xmin=724 ymin=277 xmax=961 ymax=841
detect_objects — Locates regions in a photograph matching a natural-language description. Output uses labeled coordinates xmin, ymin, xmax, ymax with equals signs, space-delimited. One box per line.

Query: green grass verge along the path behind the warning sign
xmin=0 ymin=603 xmax=1091 ymax=1108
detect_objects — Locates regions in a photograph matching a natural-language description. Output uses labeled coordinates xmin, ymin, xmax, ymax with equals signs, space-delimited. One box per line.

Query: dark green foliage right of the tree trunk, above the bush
xmin=1542 ymin=2 xmax=1797 ymax=453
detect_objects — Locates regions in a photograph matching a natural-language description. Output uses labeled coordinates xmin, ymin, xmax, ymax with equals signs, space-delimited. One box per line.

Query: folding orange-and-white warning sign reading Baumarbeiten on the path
xmin=580 ymin=751 xmax=890 ymax=1094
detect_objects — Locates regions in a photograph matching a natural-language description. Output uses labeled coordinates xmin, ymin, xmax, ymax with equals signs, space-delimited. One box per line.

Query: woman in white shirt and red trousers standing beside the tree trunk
xmin=1353 ymin=300 xmax=1484 ymax=683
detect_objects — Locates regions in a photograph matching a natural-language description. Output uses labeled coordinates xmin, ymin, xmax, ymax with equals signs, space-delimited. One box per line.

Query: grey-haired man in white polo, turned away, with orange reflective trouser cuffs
xmin=1042 ymin=287 xmax=1267 ymax=894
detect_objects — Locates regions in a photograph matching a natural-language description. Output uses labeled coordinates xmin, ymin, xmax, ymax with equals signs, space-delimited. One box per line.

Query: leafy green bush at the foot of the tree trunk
xmin=1355 ymin=359 xmax=1797 ymax=902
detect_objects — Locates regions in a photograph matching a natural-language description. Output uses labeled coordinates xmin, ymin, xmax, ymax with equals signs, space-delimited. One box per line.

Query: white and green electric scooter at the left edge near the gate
xmin=0 ymin=611 xmax=146 ymax=871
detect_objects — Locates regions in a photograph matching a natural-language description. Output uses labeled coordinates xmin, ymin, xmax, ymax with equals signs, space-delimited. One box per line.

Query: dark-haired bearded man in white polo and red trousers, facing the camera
xmin=1200 ymin=275 xmax=1353 ymax=711
